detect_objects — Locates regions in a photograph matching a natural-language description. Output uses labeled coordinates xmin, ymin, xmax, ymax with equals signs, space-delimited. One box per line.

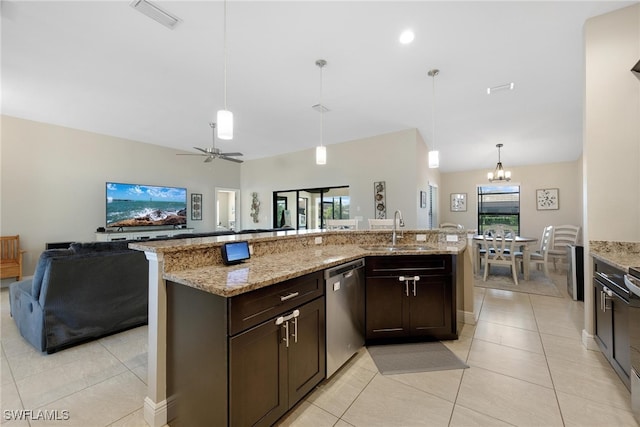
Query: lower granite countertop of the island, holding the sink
xmin=163 ymin=244 xmax=465 ymax=297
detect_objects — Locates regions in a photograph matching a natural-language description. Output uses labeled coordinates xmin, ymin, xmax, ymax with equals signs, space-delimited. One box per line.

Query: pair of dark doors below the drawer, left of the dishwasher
xmin=229 ymin=298 xmax=325 ymax=426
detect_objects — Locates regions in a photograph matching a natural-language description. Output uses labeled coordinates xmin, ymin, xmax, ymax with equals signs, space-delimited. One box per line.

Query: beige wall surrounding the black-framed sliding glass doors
xmin=242 ymin=129 xmax=439 ymax=232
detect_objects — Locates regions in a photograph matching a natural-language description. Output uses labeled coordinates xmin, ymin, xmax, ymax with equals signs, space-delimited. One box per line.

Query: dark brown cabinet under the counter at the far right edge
xmin=593 ymin=261 xmax=631 ymax=388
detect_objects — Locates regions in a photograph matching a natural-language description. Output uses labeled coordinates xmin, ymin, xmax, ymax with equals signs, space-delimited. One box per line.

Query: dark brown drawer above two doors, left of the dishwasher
xmin=229 ymin=271 xmax=324 ymax=335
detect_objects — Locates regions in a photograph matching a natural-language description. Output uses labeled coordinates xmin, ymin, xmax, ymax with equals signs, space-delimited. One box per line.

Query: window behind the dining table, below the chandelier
xmin=478 ymin=185 xmax=520 ymax=235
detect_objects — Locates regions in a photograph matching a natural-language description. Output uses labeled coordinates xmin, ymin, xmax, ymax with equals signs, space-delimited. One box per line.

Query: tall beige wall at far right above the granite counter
xmin=584 ymin=4 xmax=640 ymax=241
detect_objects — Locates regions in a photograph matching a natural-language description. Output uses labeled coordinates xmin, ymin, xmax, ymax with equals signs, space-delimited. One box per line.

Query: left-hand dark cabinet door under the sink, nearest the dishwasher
xmin=365 ymin=277 xmax=408 ymax=340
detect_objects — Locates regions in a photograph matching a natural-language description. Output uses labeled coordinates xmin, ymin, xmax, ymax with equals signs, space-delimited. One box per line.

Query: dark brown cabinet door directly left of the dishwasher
xmin=287 ymin=298 xmax=326 ymax=406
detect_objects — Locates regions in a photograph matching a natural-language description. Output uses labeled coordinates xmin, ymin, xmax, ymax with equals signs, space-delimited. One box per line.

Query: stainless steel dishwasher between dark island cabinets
xmin=324 ymin=259 xmax=364 ymax=378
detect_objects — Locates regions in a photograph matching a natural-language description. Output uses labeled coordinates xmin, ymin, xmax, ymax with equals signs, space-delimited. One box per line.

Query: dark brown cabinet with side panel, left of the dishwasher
xmin=167 ymin=272 xmax=326 ymax=427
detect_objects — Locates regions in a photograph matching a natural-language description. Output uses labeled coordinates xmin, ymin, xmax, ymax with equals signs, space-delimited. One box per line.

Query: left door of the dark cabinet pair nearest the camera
xmin=229 ymin=321 xmax=289 ymax=426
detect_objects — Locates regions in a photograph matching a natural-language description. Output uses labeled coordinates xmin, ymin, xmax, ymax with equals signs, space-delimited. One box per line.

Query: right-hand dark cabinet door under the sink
xmin=409 ymin=276 xmax=455 ymax=339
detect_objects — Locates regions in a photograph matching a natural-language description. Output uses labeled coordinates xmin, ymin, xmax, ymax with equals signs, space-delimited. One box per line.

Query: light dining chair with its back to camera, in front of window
xmin=482 ymin=226 xmax=518 ymax=285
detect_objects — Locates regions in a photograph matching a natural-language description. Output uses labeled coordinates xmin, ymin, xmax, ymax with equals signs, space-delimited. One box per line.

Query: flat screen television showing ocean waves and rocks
xmin=106 ymin=182 xmax=187 ymax=228
